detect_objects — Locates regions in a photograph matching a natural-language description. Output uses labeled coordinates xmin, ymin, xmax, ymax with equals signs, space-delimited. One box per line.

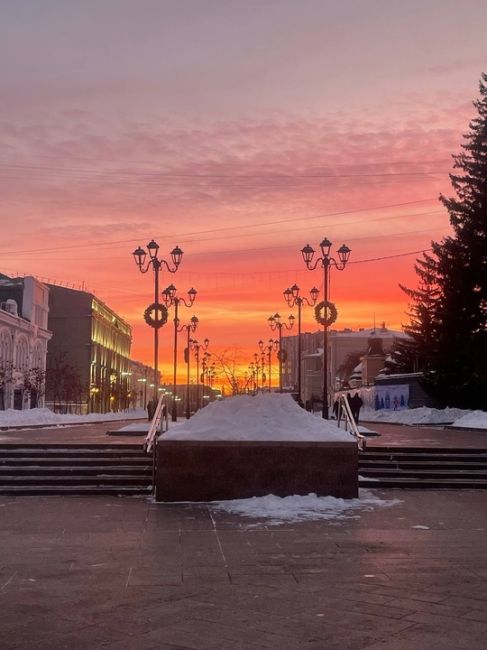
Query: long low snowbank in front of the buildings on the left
xmin=0 ymin=408 xmax=147 ymax=427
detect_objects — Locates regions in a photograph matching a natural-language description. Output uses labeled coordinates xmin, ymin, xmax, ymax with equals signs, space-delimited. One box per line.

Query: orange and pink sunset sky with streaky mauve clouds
xmin=0 ymin=0 xmax=487 ymax=380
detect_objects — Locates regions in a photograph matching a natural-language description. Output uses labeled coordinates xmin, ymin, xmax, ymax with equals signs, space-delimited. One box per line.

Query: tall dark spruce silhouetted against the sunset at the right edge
xmin=396 ymin=74 xmax=487 ymax=409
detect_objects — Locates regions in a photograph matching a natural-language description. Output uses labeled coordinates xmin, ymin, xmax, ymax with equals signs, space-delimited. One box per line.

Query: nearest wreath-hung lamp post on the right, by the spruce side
xmin=301 ymin=237 xmax=352 ymax=420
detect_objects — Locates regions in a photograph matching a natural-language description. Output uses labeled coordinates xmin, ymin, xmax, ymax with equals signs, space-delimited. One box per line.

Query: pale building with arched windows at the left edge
xmin=0 ymin=274 xmax=51 ymax=410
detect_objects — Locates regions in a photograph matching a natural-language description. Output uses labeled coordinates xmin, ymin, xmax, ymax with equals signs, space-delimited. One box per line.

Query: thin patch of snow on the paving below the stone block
xmin=210 ymin=489 xmax=401 ymax=526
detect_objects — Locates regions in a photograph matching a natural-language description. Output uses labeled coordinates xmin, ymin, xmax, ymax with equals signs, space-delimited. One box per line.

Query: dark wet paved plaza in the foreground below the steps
xmin=0 ymin=490 xmax=487 ymax=650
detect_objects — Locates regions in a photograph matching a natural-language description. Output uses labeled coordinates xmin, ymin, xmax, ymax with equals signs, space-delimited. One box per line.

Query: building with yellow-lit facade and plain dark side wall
xmin=46 ymin=285 xmax=132 ymax=413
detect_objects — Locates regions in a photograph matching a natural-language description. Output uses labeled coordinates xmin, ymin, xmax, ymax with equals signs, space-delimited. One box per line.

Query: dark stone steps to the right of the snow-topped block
xmin=359 ymin=447 xmax=487 ymax=489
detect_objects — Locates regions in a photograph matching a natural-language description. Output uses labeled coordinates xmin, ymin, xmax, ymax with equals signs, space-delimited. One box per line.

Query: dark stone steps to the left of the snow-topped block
xmin=0 ymin=444 xmax=152 ymax=496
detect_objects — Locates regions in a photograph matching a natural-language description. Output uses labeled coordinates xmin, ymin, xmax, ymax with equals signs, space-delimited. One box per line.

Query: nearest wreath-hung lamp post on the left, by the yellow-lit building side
xmin=133 ymin=239 xmax=183 ymax=400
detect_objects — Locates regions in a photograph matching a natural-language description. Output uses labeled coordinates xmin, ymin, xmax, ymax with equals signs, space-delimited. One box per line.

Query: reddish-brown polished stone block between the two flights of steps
xmin=156 ymin=436 xmax=358 ymax=501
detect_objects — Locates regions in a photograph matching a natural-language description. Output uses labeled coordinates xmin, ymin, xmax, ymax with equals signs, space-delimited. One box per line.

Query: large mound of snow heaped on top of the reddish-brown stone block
xmin=163 ymin=393 xmax=355 ymax=442
